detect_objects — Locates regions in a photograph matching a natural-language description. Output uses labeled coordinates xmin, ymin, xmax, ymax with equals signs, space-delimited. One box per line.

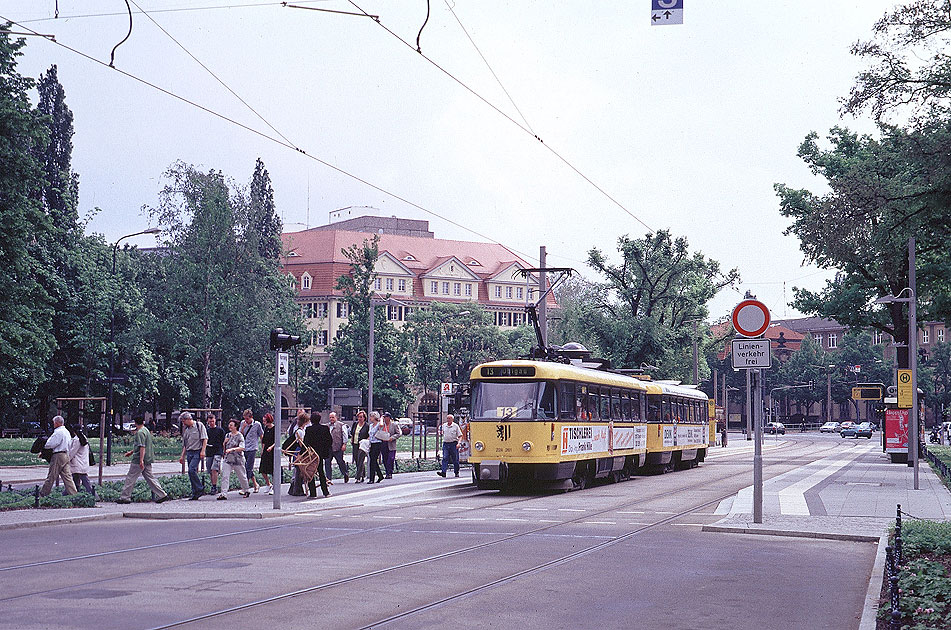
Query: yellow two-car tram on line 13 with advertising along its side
xmin=469 ymin=360 xmax=716 ymax=489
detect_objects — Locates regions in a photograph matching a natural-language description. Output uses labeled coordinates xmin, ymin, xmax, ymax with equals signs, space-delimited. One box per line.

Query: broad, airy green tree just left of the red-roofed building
xmin=151 ymin=163 xmax=299 ymax=409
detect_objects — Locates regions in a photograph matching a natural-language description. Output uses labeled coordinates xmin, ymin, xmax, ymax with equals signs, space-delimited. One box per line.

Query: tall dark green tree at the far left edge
xmin=0 ymin=33 xmax=55 ymax=417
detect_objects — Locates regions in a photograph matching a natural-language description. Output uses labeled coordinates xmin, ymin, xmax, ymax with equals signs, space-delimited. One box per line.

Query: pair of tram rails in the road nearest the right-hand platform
xmin=141 ymin=441 xmax=848 ymax=630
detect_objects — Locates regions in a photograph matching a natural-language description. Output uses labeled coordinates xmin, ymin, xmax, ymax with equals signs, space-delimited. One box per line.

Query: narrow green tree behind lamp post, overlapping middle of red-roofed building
xmin=320 ymin=235 xmax=412 ymax=415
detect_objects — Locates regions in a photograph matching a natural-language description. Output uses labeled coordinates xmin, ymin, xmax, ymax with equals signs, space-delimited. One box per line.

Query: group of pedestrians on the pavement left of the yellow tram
xmin=40 ymin=409 xmax=462 ymax=503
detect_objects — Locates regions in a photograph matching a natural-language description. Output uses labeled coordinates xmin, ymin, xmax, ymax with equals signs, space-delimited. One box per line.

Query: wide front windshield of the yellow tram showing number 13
xmin=472 ymin=381 xmax=555 ymax=420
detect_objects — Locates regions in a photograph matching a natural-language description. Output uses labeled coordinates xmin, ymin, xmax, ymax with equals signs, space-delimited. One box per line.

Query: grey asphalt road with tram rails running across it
xmin=0 ymin=434 xmax=875 ymax=630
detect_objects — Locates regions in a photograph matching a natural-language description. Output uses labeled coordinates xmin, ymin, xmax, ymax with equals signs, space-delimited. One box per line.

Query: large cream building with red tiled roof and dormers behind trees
xmin=281 ymin=216 xmax=557 ymax=367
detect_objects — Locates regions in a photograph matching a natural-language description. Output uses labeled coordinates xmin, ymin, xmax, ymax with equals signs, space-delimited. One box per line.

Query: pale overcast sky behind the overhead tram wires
xmin=0 ymin=0 xmax=894 ymax=318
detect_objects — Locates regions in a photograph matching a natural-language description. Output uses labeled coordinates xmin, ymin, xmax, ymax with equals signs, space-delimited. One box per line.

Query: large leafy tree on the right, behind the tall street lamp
xmin=775 ymin=127 xmax=951 ymax=365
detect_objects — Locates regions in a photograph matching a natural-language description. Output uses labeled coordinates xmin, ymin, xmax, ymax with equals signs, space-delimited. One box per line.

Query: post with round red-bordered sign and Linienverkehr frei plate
xmin=732 ymin=299 xmax=772 ymax=523
